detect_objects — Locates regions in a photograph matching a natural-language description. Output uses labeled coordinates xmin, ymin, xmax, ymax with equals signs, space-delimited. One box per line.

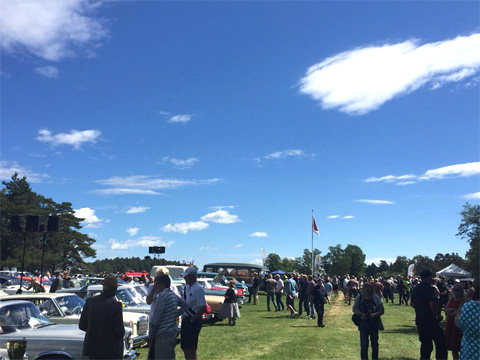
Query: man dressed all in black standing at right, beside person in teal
xmin=410 ymin=270 xmax=447 ymax=359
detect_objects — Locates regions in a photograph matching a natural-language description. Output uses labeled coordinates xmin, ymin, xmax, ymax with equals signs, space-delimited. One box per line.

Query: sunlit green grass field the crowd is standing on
xmin=139 ymin=294 xmax=420 ymax=360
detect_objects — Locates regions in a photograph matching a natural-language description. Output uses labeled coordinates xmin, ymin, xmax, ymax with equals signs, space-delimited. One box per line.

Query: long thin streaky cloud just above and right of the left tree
xmin=91 ymin=175 xmax=221 ymax=195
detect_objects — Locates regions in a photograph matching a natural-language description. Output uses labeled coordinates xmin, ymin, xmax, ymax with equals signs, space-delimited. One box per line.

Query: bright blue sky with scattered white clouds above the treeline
xmin=0 ymin=0 xmax=480 ymax=265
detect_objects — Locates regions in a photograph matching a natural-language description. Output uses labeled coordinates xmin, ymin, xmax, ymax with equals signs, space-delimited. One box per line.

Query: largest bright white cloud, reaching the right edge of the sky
xmin=300 ymin=34 xmax=480 ymax=115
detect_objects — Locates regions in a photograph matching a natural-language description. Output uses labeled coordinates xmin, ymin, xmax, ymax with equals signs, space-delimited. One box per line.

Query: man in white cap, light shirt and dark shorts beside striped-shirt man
xmin=181 ymin=266 xmax=207 ymax=360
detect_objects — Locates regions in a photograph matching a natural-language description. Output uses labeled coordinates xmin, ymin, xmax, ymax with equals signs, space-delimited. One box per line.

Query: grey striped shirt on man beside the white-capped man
xmin=150 ymin=289 xmax=189 ymax=336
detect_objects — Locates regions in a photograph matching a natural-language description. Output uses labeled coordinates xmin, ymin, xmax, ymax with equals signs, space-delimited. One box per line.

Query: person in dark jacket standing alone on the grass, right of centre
xmin=353 ymin=282 xmax=385 ymax=360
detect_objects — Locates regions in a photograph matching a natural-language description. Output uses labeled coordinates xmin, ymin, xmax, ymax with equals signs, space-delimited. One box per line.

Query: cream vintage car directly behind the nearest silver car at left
xmin=0 ymin=292 xmax=148 ymax=348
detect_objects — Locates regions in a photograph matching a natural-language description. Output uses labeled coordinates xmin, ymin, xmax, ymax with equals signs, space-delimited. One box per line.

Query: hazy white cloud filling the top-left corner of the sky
xmin=0 ymin=0 xmax=108 ymax=61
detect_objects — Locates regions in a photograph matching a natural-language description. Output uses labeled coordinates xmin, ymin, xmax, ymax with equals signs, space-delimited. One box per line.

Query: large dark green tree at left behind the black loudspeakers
xmin=0 ymin=173 xmax=96 ymax=271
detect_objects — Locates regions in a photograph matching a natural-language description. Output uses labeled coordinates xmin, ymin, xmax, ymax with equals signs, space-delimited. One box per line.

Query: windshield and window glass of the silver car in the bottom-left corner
xmin=0 ymin=303 xmax=53 ymax=334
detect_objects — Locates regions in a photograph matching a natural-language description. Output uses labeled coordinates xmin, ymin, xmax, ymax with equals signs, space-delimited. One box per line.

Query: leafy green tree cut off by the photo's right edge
xmin=457 ymin=202 xmax=480 ymax=276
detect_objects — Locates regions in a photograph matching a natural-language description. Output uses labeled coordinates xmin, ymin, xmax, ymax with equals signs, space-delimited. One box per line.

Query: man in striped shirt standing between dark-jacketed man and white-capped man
xmin=150 ymin=275 xmax=189 ymax=360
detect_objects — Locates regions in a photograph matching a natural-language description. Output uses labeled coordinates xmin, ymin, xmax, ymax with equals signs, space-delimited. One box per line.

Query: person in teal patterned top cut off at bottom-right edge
xmin=455 ymin=278 xmax=480 ymax=360
